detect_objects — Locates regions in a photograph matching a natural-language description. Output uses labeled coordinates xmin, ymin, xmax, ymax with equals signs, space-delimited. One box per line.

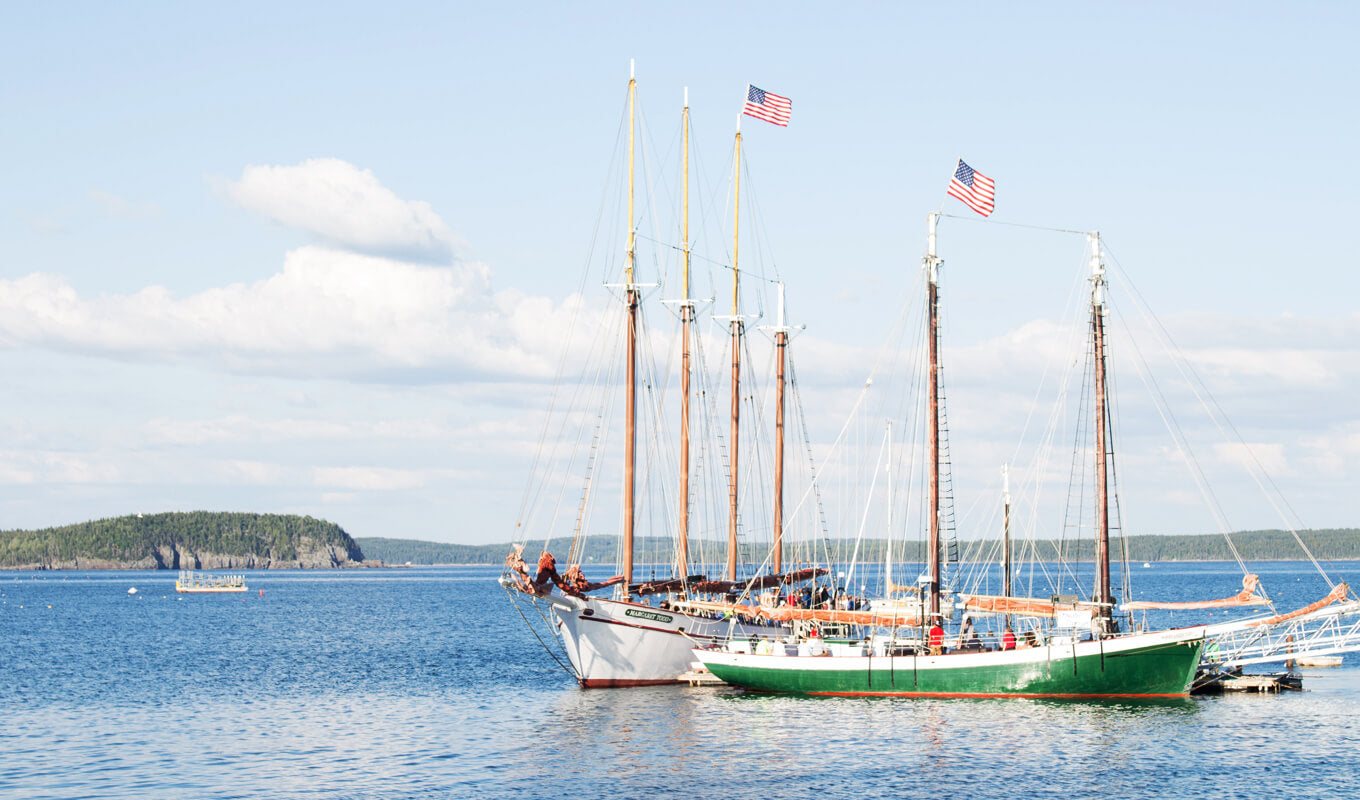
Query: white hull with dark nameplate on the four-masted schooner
xmin=549 ymin=596 xmax=781 ymax=688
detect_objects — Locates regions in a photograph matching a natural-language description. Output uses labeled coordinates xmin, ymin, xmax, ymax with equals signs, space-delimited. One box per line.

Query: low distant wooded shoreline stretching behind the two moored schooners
xmin=355 ymin=528 xmax=1360 ymax=565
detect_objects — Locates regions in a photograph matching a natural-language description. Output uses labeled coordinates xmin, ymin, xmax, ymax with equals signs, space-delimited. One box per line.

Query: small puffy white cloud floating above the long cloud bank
xmin=224 ymin=158 xmax=456 ymax=261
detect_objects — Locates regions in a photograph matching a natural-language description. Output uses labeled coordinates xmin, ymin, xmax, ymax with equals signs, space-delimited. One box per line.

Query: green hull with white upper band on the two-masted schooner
xmin=696 ymin=630 xmax=1204 ymax=697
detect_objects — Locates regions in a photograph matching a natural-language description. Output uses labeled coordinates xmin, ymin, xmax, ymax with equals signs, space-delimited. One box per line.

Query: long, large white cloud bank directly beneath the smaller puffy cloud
xmin=0 ymin=246 xmax=579 ymax=381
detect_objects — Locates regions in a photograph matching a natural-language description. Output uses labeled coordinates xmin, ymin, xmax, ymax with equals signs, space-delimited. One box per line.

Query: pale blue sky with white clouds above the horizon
xmin=0 ymin=3 xmax=1360 ymax=541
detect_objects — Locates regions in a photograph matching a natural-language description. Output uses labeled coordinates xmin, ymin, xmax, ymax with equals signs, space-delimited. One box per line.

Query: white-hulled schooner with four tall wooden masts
xmin=500 ymin=63 xmax=827 ymax=687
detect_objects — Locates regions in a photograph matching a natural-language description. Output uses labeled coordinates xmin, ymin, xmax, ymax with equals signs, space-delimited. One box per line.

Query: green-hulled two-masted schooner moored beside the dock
xmin=695 ymin=214 xmax=1205 ymax=698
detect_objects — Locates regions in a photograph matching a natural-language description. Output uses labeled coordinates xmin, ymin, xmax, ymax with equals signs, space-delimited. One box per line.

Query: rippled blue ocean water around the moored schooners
xmin=0 ymin=563 xmax=1360 ymax=799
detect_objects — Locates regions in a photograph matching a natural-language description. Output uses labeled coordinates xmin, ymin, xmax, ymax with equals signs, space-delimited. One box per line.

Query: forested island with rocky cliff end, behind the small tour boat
xmin=0 ymin=512 xmax=381 ymax=570
